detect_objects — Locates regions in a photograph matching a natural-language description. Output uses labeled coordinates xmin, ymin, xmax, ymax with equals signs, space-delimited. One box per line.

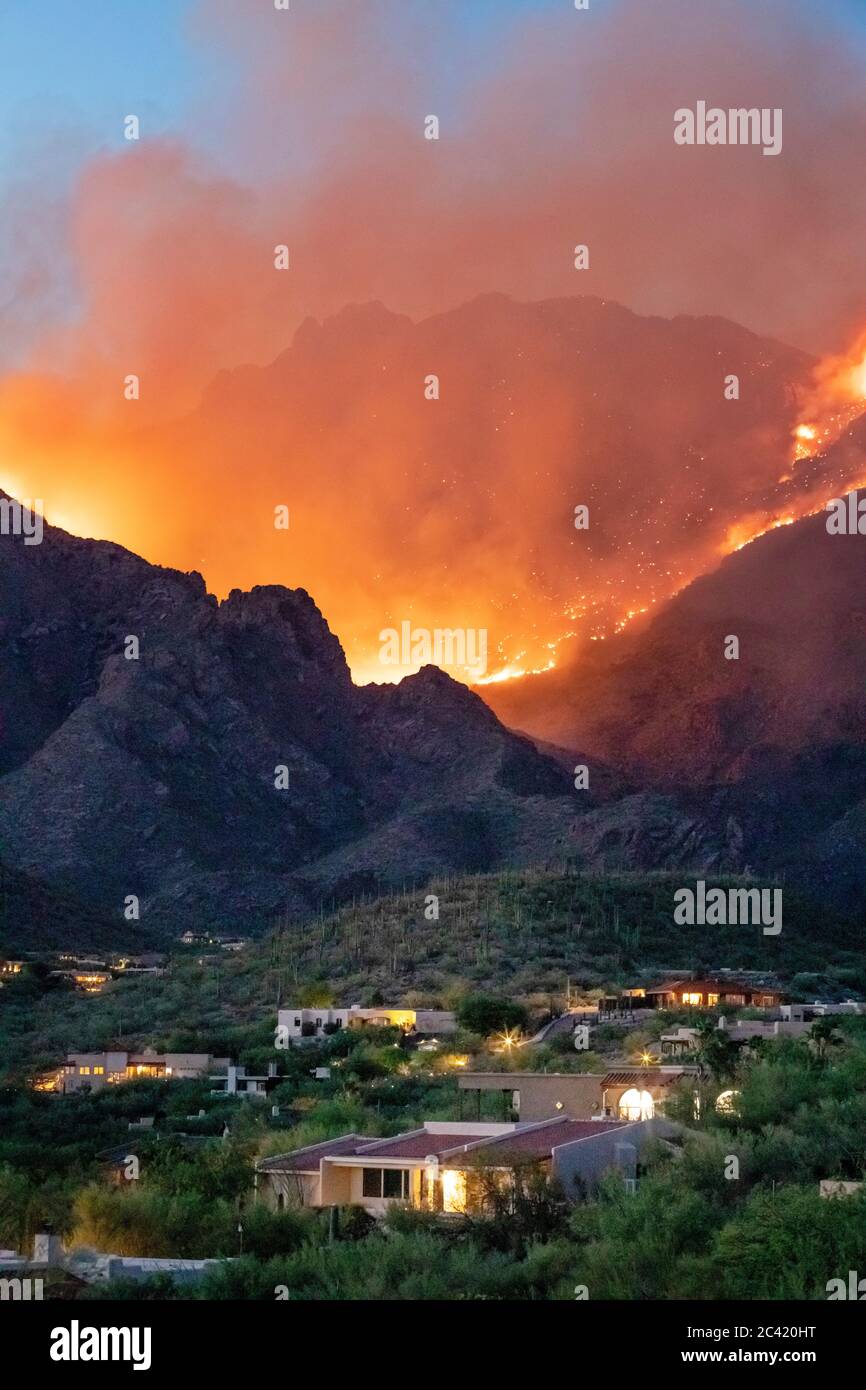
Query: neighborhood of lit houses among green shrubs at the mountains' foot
xmin=0 ymin=878 xmax=866 ymax=1300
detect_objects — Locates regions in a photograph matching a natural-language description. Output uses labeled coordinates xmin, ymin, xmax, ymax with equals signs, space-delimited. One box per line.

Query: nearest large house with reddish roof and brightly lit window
xmin=256 ymin=1116 xmax=674 ymax=1216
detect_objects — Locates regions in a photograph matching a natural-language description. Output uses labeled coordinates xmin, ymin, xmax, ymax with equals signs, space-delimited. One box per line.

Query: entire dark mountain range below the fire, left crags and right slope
xmin=0 ymin=436 xmax=866 ymax=938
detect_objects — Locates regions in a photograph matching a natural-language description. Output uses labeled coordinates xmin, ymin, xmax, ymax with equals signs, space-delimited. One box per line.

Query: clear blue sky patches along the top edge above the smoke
xmin=0 ymin=0 xmax=866 ymax=179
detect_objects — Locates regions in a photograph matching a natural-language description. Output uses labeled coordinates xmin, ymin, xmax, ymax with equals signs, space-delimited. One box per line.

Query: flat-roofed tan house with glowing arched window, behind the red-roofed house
xmin=457 ymin=1066 xmax=696 ymax=1120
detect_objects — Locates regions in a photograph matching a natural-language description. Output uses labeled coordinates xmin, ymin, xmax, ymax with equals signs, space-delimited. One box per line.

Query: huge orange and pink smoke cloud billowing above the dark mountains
xmin=0 ymin=0 xmax=866 ymax=684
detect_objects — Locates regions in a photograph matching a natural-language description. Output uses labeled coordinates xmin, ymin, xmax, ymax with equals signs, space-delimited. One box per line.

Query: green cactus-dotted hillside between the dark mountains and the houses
xmin=0 ymin=872 xmax=866 ymax=1073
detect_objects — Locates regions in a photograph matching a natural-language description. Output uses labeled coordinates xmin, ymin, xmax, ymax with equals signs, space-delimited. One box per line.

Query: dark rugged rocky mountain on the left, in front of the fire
xmin=0 ymin=500 xmax=583 ymax=930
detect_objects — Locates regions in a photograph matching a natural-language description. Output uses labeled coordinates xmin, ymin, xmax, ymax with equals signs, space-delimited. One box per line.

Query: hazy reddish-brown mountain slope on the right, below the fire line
xmin=485 ymin=464 xmax=866 ymax=908
